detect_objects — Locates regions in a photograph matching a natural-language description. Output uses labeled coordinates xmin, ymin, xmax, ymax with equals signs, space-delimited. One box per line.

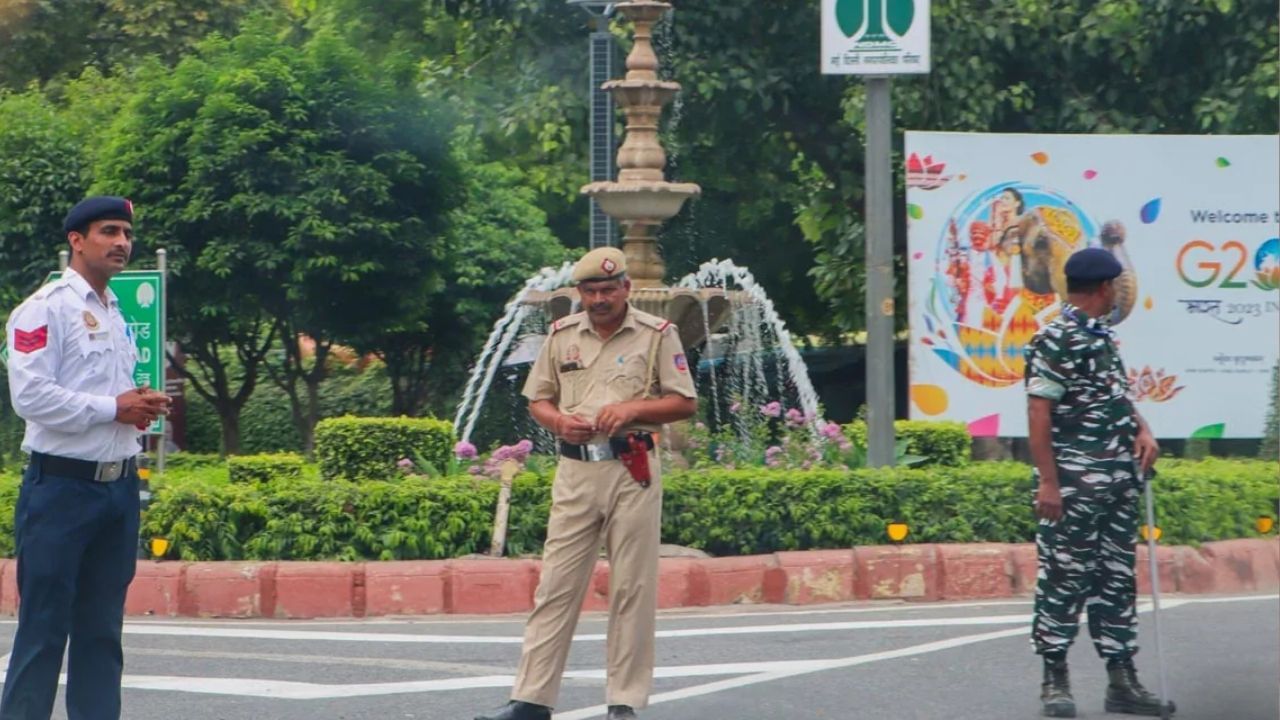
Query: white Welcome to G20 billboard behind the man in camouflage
xmin=906 ymin=132 xmax=1280 ymax=438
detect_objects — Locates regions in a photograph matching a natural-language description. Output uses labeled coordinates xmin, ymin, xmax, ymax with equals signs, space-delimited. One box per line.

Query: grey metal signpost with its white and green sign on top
xmin=822 ymin=0 xmax=929 ymax=466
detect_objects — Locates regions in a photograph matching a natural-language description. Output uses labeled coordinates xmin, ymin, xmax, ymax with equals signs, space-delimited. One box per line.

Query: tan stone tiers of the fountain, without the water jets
xmin=529 ymin=0 xmax=730 ymax=347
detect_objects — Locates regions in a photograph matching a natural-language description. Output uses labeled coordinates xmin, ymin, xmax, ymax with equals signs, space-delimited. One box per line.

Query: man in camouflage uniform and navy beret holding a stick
xmin=1025 ymin=249 xmax=1172 ymax=717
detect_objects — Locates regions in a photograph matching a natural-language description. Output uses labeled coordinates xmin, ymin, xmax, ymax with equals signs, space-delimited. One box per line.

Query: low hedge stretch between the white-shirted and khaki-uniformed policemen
xmin=142 ymin=475 xmax=550 ymax=560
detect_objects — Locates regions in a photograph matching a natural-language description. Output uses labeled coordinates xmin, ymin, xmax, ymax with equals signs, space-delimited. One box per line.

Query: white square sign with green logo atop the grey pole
xmin=822 ymin=0 xmax=929 ymax=76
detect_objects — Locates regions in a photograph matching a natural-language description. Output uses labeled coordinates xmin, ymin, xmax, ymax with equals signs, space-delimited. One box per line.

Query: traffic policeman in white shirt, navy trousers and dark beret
xmin=0 ymin=196 xmax=169 ymax=720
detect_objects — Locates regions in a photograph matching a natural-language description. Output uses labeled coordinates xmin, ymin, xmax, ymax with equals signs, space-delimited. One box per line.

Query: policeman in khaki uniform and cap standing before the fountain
xmin=476 ymin=247 xmax=698 ymax=720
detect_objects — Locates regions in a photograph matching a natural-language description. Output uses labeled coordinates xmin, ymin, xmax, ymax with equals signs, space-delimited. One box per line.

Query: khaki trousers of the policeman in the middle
xmin=511 ymin=452 xmax=662 ymax=708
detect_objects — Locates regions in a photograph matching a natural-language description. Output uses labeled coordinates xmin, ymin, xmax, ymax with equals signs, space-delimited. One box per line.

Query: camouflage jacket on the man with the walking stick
xmin=1024 ymin=304 xmax=1138 ymax=476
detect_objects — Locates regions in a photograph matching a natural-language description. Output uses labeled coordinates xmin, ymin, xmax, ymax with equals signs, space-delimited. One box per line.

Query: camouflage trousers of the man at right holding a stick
xmin=1032 ymin=473 xmax=1140 ymax=660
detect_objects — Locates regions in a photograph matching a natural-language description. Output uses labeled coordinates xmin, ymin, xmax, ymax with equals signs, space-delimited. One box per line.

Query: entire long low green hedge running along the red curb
xmin=115 ymin=460 xmax=1280 ymax=560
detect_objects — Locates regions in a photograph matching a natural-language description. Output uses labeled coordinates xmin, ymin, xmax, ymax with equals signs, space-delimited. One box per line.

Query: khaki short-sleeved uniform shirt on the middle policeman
xmin=524 ymin=305 xmax=698 ymax=442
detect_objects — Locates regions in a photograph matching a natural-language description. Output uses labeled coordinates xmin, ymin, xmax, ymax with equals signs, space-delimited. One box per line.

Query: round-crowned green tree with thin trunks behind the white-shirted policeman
xmin=99 ymin=18 xmax=454 ymax=450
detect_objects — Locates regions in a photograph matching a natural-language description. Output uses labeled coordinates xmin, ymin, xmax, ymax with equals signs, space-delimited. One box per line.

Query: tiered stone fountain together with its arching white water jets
xmin=453 ymin=0 xmax=818 ymax=451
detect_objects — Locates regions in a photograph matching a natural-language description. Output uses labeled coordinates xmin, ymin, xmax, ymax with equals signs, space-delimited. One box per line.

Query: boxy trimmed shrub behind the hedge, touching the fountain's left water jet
xmin=316 ymin=415 xmax=453 ymax=480
